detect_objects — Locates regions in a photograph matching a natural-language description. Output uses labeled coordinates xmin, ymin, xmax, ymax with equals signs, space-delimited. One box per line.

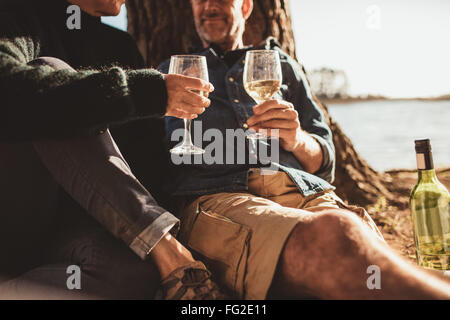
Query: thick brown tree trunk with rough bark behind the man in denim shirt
xmin=127 ymin=0 xmax=395 ymax=205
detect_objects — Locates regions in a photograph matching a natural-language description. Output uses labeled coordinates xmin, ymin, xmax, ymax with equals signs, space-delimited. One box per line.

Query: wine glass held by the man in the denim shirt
xmin=243 ymin=50 xmax=282 ymax=139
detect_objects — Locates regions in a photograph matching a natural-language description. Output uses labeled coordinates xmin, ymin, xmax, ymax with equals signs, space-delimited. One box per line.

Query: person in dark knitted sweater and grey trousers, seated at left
xmin=0 ymin=0 xmax=219 ymax=299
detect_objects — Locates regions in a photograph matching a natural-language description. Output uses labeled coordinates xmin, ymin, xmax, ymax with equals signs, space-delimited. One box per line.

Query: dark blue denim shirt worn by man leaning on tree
xmin=158 ymin=38 xmax=335 ymax=196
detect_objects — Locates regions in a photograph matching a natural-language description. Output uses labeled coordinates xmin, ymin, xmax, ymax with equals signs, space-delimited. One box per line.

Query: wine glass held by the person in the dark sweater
xmin=169 ymin=55 xmax=209 ymax=155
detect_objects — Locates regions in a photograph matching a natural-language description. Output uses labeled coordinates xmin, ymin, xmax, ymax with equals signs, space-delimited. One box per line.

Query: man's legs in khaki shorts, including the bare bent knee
xmin=180 ymin=173 xmax=450 ymax=299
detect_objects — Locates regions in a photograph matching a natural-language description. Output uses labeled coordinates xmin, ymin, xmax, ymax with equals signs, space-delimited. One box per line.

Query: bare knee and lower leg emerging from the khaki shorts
xmin=272 ymin=209 xmax=450 ymax=299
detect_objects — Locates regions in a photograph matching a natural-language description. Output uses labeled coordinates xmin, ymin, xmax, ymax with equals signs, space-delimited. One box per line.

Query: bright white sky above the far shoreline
xmin=104 ymin=0 xmax=450 ymax=98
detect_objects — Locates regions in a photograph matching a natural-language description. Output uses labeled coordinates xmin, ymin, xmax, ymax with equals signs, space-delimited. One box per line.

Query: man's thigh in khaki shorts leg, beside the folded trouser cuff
xmin=180 ymin=193 xmax=314 ymax=299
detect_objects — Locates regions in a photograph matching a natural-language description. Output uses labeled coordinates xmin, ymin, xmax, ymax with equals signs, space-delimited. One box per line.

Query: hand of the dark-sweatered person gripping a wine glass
xmin=164 ymin=74 xmax=214 ymax=119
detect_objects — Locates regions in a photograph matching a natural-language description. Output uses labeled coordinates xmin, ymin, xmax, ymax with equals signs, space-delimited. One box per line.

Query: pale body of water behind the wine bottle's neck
xmin=328 ymin=100 xmax=450 ymax=171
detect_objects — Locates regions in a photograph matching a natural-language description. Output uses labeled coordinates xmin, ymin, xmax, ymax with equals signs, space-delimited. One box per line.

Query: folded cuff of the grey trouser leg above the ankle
xmin=130 ymin=211 xmax=180 ymax=260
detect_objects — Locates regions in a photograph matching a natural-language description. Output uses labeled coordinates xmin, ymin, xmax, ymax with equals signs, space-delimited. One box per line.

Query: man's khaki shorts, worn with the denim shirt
xmin=179 ymin=171 xmax=383 ymax=300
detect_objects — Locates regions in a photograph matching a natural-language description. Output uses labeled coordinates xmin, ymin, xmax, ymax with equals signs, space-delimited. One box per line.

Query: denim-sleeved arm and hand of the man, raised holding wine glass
xmin=247 ymin=58 xmax=335 ymax=182
